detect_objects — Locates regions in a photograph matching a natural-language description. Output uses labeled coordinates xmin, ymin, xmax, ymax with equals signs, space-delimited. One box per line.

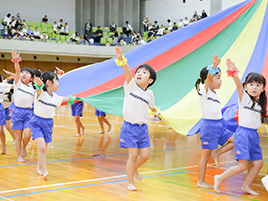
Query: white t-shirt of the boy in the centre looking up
xmin=123 ymin=78 xmax=154 ymax=124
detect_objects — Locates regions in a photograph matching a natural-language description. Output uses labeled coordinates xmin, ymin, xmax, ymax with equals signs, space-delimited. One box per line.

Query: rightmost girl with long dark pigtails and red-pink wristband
xmin=214 ymin=59 xmax=267 ymax=195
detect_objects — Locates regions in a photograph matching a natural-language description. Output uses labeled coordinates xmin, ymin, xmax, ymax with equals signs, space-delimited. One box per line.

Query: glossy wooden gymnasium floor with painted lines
xmin=0 ymin=104 xmax=268 ymax=201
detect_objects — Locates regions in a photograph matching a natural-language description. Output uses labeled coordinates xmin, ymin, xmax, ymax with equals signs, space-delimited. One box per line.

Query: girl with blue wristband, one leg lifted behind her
xmin=195 ymin=55 xmax=234 ymax=188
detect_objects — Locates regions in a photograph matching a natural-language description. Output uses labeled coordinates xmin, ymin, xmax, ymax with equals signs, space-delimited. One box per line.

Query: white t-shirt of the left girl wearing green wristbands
xmin=34 ymin=90 xmax=62 ymax=118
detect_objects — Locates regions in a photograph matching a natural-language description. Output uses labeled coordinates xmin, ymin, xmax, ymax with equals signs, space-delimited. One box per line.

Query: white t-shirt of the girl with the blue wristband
xmin=199 ymin=84 xmax=222 ymax=120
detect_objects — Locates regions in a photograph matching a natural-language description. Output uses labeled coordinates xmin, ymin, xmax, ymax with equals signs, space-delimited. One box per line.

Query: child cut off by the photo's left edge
xmin=0 ymin=74 xmax=12 ymax=154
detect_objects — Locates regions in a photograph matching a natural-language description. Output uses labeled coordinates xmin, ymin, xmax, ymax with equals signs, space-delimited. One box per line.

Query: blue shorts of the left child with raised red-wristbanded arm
xmin=11 ymin=106 xmax=33 ymax=130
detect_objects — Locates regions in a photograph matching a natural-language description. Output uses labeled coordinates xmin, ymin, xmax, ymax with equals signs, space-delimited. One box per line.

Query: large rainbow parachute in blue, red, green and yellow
xmin=58 ymin=0 xmax=268 ymax=135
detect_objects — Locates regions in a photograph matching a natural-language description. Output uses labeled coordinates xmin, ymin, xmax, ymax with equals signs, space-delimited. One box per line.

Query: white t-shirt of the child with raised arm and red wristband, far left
xmin=14 ymin=79 xmax=35 ymax=108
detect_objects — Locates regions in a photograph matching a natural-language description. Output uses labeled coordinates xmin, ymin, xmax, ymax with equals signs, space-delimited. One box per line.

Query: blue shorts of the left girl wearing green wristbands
xmin=30 ymin=115 xmax=53 ymax=143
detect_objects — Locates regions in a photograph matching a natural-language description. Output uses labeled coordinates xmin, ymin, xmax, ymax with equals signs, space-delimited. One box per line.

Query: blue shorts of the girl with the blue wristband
xmin=200 ymin=119 xmax=233 ymax=149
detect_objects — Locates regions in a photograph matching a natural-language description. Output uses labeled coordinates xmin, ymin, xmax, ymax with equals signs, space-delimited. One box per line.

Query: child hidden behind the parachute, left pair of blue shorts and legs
xmin=71 ymin=101 xmax=85 ymax=137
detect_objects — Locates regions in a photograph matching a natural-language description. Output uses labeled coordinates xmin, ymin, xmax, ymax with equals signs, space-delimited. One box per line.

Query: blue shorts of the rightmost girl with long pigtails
xmin=234 ymin=126 xmax=262 ymax=161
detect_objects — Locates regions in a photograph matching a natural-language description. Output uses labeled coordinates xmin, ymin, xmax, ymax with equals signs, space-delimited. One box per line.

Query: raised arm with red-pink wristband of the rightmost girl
xmin=226 ymin=59 xmax=244 ymax=100
